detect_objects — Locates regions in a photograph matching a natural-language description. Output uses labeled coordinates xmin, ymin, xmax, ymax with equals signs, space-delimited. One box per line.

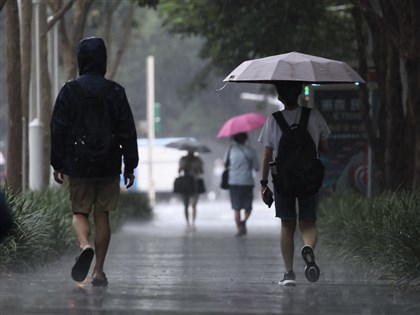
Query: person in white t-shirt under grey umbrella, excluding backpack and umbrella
xmin=258 ymin=82 xmax=330 ymax=285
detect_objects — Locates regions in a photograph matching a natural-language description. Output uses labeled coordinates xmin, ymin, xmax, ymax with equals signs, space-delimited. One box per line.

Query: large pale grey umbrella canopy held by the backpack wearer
xmin=223 ymin=52 xmax=365 ymax=83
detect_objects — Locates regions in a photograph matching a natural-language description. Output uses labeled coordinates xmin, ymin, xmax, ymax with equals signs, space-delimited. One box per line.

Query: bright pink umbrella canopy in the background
xmin=217 ymin=113 xmax=267 ymax=138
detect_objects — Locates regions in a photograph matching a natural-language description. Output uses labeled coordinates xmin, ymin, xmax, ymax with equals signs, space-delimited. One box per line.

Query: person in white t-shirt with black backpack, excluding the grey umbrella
xmin=258 ymin=82 xmax=330 ymax=286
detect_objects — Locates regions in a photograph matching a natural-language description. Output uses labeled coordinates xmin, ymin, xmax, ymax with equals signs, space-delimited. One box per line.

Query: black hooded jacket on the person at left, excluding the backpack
xmin=51 ymin=37 xmax=139 ymax=177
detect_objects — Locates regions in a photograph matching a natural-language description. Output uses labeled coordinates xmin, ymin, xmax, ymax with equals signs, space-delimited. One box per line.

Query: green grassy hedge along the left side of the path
xmin=0 ymin=188 xmax=152 ymax=271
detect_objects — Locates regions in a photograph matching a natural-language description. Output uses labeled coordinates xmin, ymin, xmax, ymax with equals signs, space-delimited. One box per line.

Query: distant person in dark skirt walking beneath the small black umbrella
xmin=178 ymin=151 xmax=204 ymax=229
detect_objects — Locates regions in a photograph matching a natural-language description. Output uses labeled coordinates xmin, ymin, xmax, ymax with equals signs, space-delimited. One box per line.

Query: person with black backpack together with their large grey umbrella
xmin=218 ymin=52 xmax=365 ymax=285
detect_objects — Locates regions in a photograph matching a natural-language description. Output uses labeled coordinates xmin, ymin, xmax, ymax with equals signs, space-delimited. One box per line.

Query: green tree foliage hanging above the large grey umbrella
xmin=159 ymin=0 xmax=354 ymax=76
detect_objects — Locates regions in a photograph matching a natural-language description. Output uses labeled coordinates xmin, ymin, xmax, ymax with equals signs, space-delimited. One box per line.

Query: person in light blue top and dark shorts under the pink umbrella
xmin=224 ymin=132 xmax=260 ymax=237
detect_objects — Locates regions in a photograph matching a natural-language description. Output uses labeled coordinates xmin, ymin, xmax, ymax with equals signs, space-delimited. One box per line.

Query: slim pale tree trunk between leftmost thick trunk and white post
xmin=20 ymin=1 xmax=32 ymax=189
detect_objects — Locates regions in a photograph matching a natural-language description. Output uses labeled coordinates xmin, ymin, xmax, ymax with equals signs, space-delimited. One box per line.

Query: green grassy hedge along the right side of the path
xmin=318 ymin=191 xmax=420 ymax=288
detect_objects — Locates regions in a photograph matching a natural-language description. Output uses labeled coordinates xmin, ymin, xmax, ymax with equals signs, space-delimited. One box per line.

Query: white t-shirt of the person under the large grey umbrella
xmin=258 ymin=107 xmax=331 ymax=157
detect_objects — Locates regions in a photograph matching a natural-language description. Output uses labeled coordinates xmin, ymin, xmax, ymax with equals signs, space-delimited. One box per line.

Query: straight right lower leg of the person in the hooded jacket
xmin=94 ymin=211 xmax=111 ymax=277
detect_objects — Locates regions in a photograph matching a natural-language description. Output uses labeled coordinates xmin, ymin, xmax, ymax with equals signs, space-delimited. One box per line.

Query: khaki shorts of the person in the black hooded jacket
xmin=69 ymin=176 xmax=120 ymax=214
